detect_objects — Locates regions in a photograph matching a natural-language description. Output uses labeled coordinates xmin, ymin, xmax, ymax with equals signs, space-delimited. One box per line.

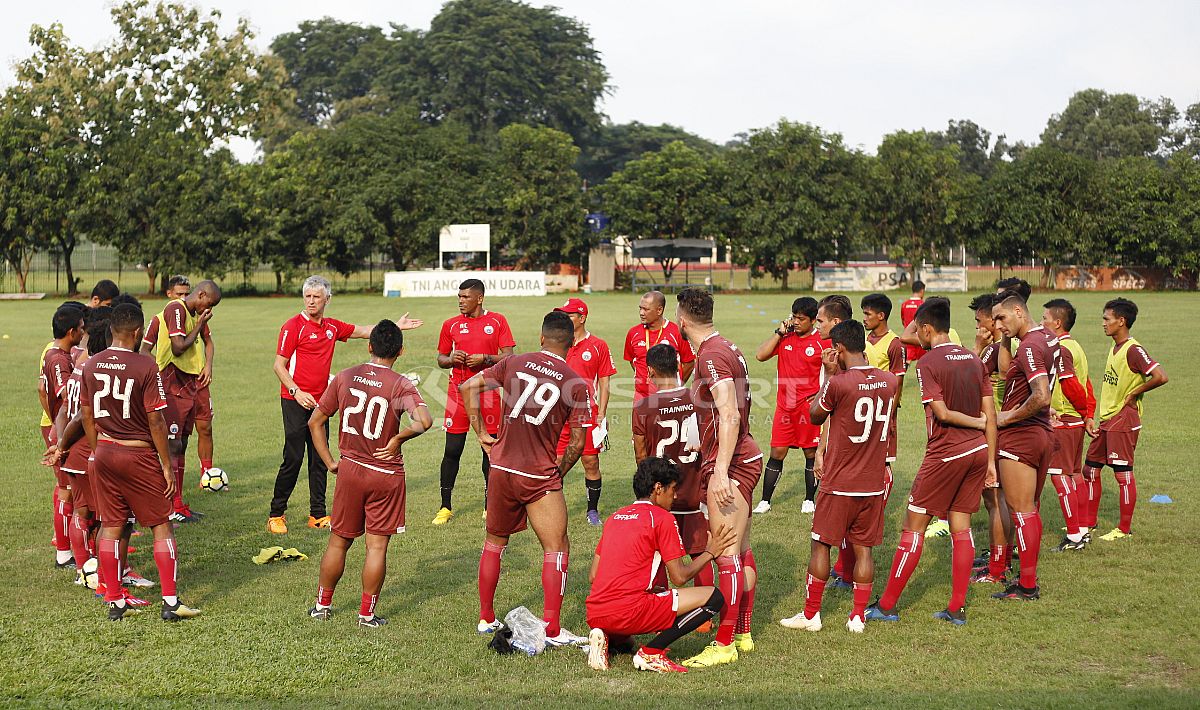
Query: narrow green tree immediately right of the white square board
xmin=491 ymin=124 xmax=592 ymax=269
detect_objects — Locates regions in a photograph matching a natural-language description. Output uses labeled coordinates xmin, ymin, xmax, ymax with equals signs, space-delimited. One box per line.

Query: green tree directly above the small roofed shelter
xmin=599 ymin=140 xmax=726 ymax=281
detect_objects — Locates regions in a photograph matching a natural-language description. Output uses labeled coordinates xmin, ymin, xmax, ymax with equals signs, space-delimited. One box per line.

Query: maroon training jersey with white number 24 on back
xmin=79 ymin=347 xmax=167 ymax=444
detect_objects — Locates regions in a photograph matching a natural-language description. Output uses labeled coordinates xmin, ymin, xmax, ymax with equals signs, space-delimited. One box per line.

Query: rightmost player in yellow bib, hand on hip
xmin=1084 ymin=299 xmax=1168 ymax=542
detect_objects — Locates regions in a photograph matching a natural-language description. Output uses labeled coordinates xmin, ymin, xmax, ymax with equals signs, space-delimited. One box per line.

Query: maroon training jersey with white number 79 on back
xmin=484 ymin=350 xmax=592 ymax=479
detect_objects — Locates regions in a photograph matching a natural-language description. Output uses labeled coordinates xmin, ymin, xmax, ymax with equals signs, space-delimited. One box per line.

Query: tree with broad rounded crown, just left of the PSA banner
xmin=725 ymin=121 xmax=865 ymax=289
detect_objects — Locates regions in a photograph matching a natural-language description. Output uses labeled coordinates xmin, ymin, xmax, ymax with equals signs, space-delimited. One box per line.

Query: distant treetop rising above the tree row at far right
xmin=1042 ymin=89 xmax=1178 ymax=160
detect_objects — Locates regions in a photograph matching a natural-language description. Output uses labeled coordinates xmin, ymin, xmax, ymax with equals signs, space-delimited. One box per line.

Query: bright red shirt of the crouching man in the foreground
xmin=587 ymin=500 xmax=684 ymax=607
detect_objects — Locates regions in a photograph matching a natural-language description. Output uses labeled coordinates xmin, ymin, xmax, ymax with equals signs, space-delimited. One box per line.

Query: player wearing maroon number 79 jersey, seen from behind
xmin=460 ymin=311 xmax=592 ymax=646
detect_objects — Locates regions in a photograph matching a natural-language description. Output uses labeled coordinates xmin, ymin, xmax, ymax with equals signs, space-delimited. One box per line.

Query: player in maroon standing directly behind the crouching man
xmin=634 ymin=343 xmax=716 ymax=586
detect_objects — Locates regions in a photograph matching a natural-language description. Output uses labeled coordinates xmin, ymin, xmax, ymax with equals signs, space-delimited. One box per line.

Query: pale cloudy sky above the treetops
xmin=0 ymin=0 xmax=1200 ymax=152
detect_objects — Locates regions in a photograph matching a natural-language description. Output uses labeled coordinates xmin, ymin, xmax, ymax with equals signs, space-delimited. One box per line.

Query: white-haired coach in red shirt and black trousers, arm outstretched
xmin=266 ymin=276 xmax=422 ymax=535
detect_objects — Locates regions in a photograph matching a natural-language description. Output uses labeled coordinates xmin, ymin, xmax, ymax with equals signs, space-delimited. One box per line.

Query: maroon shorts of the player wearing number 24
xmin=89 ymin=440 xmax=172 ymax=528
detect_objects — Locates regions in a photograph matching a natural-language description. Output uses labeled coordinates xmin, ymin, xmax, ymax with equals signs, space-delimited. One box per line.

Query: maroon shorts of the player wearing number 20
xmin=330 ymin=457 xmax=404 ymax=537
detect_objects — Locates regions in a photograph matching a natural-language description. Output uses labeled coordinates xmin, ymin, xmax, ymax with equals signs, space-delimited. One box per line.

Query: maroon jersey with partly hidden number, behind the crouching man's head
xmin=634 ymin=385 xmax=700 ymax=513
